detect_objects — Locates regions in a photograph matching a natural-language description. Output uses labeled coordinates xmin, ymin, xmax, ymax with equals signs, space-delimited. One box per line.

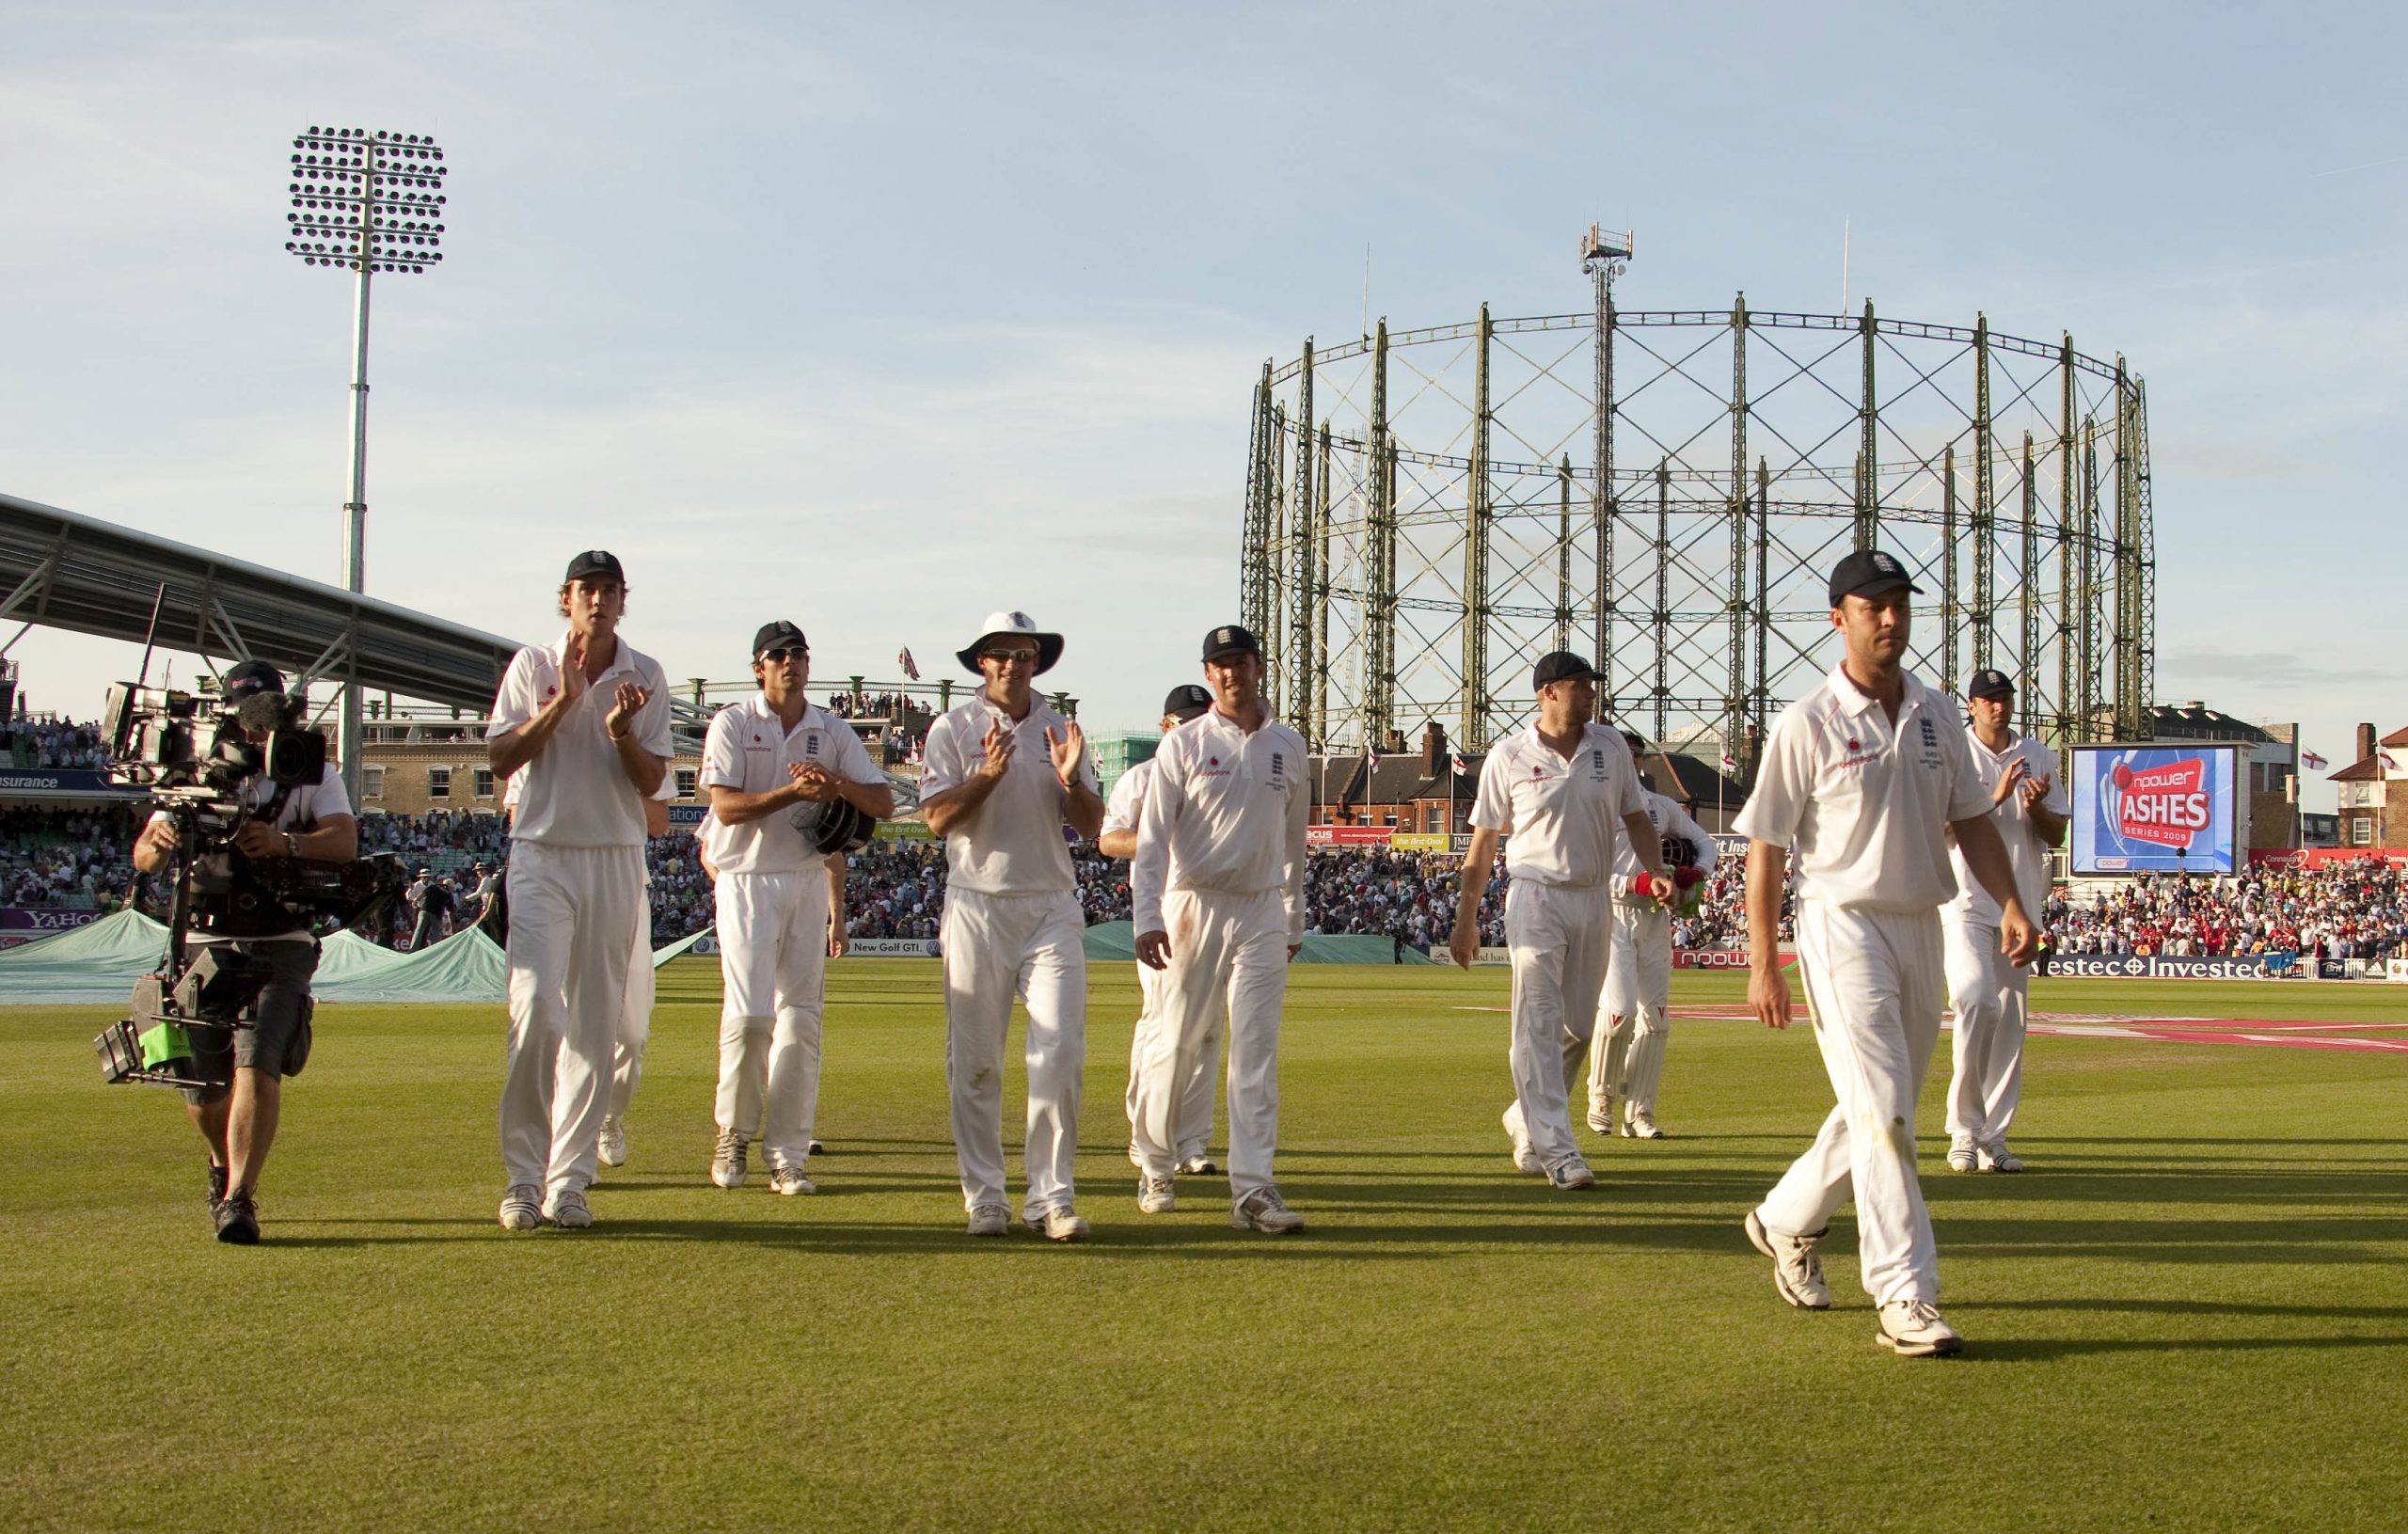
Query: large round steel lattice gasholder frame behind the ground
xmin=1240 ymin=273 xmax=2155 ymax=781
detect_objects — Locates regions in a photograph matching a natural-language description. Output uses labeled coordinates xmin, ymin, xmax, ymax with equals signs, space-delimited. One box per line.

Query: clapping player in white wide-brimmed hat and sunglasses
xmin=920 ymin=611 xmax=1102 ymax=1241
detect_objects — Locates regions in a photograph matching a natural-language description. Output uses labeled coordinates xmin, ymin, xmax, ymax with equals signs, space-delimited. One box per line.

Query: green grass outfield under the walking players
xmin=0 ymin=961 xmax=2408 ymax=1534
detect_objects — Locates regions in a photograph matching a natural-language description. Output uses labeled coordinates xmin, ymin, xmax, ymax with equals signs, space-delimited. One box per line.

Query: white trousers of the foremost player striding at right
xmin=1758 ymin=901 xmax=1945 ymax=1305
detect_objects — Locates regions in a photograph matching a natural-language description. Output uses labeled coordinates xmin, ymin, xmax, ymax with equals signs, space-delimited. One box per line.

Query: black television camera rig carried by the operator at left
xmin=94 ymin=667 xmax=407 ymax=1086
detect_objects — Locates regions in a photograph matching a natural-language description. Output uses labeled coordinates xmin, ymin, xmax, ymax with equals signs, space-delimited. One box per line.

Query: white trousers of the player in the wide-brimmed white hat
xmin=937 ymin=886 xmax=1086 ymax=1219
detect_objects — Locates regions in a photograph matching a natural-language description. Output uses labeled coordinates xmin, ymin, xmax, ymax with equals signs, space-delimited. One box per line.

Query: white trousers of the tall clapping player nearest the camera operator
xmin=500 ymin=841 xmax=643 ymax=1202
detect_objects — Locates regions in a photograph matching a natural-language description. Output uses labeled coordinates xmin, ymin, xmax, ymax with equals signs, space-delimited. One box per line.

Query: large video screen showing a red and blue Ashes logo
xmin=2068 ymin=747 xmax=2240 ymax=874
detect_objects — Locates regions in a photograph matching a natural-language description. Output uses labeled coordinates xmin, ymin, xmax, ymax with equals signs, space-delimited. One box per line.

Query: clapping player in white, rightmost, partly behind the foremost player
xmin=1941 ymin=670 xmax=2073 ymax=1173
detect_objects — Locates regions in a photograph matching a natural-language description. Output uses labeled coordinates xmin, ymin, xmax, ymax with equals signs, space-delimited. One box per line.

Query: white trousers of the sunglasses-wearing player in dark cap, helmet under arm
xmin=713 ymin=869 xmax=829 ymax=1170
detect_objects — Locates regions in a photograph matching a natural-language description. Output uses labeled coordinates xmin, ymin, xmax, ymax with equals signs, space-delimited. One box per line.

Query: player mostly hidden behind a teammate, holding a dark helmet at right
xmin=1590 ymin=735 xmax=1719 ymax=1139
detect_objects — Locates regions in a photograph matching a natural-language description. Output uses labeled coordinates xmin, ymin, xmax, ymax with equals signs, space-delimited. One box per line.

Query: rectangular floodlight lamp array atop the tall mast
xmin=284 ymin=128 xmax=448 ymax=272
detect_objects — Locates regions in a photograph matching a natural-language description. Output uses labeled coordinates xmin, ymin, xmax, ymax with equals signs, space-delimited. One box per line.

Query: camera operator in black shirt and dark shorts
xmin=135 ymin=660 xmax=358 ymax=1245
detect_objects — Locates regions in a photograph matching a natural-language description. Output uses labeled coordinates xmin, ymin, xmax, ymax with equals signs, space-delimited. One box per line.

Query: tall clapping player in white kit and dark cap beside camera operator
xmin=486 ymin=549 xmax=672 ymax=1230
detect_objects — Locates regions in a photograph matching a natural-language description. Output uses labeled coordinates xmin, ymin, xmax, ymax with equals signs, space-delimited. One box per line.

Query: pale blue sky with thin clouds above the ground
xmin=0 ymin=3 xmax=2408 ymax=807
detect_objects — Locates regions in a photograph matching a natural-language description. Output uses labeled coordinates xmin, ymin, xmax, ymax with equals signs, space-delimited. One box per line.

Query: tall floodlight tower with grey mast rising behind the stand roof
xmin=284 ymin=128 xmax=446 ymax=807
